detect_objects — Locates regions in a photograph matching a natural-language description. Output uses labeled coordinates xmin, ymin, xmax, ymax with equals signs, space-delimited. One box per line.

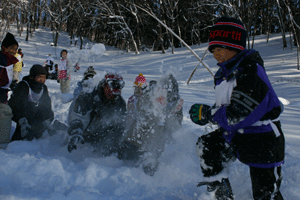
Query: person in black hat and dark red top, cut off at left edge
xmin=0 ymin=32 xmax=19 ymax=148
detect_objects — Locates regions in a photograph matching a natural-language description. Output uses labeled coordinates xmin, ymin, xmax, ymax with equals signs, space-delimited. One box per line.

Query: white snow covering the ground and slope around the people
xmin=0 ymin=26 xmax=300 ymax=200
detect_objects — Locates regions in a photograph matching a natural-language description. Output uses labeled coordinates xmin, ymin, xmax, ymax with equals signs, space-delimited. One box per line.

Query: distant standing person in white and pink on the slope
xmin=58 ymin=49 xmax=72 ymax=94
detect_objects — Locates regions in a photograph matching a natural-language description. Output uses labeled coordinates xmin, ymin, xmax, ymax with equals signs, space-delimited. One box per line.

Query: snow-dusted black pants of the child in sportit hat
xmin=196 ymin=129 xmax=283 ymax=200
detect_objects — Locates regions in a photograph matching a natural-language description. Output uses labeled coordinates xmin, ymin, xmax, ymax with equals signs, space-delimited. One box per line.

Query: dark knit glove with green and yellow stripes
xmin=189 ymin=104 xmax=212 ymax=126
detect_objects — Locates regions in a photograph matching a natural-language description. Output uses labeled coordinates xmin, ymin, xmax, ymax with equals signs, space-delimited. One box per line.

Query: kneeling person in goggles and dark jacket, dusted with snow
xmin=68 ymin=71 xmax=126 ymax=156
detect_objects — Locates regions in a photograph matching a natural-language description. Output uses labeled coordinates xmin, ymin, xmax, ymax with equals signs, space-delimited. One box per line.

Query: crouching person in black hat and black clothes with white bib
xmin=8 ymin=65 xmax=54 ymax=141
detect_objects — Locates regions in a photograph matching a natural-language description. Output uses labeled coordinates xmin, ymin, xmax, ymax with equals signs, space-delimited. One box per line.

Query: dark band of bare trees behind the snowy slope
xmin=0 ymin=0 xmax=300 ymax=61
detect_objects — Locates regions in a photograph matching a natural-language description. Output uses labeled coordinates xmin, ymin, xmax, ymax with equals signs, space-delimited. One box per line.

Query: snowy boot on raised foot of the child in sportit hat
xmin=197 ymin=178 xmax=233 ymax=200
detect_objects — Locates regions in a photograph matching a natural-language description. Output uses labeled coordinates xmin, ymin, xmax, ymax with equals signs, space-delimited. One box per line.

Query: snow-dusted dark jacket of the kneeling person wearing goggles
xmin=68 ymin=84 xmax=126 ymax=155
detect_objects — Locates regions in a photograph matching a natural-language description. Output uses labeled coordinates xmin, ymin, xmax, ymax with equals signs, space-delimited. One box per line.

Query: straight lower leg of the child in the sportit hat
xmin=250 ymin=167 xmax=283 ymax=200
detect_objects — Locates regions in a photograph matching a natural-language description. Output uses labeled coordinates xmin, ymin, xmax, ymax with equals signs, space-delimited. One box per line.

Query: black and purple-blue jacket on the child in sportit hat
xmin=213 ymin=49 xmax=284 ymax=168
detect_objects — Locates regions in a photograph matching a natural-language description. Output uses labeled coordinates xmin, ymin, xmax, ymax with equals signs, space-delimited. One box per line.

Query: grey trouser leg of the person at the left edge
xmin=0 ymin=103 xmax=13 ymax=149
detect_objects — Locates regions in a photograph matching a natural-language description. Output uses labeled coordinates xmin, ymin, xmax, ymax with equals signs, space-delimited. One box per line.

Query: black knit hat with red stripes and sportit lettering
xmin=208 ymin=17 xmax=247 ymax=52
